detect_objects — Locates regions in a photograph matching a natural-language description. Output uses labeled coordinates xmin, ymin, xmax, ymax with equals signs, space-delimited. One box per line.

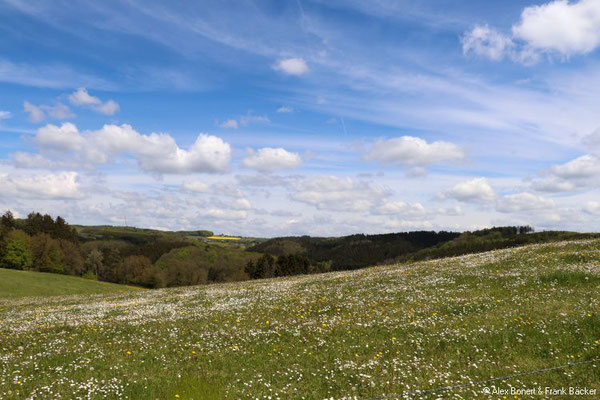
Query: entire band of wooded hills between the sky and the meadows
xmin=0 ymin=211 xmax=598 ymax=288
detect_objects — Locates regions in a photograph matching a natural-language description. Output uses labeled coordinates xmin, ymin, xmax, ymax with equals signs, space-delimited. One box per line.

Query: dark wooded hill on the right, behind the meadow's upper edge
xmin=248 ymin=226 xmax=600 ymax=271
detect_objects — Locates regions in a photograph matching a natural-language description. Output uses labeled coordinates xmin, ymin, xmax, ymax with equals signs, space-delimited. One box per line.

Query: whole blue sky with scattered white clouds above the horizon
xmin=0 ymin=0 xmax=600 ymax=237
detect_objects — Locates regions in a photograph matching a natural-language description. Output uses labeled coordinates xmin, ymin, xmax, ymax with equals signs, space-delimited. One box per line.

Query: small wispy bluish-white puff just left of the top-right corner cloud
xmin=461 ymin=25 xmax=514 ymax=61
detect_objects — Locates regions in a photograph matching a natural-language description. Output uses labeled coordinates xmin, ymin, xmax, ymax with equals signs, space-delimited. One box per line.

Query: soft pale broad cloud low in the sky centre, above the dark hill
xmin=290 ymin=175 xmax=390 ymax=212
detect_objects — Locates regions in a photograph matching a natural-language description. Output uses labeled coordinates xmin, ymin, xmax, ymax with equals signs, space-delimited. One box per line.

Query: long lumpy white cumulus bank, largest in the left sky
xmin=15 ymin=123 xmax=231 ymax=174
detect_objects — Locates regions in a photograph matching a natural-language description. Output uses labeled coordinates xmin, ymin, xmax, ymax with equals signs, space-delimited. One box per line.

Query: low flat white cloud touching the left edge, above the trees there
xmin=0 ymin=172 xmax=81 ymax=199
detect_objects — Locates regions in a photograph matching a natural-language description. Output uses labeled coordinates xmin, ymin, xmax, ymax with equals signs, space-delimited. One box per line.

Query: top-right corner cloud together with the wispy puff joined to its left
xmin=462 ymin=0 xmax=600 ymax=64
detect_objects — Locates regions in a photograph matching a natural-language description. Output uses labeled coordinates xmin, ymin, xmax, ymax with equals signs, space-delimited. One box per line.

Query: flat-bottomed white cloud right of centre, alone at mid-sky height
xmin=365 ymin=136 xmax=465 ymax=175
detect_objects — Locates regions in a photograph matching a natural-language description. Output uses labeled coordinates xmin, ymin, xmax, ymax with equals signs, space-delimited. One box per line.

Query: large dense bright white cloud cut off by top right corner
xmin=512 ymin=0 xmax=600 ymax=56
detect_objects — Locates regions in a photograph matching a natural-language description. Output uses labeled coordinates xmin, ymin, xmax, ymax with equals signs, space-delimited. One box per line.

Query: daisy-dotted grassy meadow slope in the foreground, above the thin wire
xmin=0 ymin=240 xmax=600 ymax=399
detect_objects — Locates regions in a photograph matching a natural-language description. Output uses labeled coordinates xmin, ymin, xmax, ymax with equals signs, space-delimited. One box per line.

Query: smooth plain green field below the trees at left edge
xmin=0 ymin=268 xmax=142 ymax=298
